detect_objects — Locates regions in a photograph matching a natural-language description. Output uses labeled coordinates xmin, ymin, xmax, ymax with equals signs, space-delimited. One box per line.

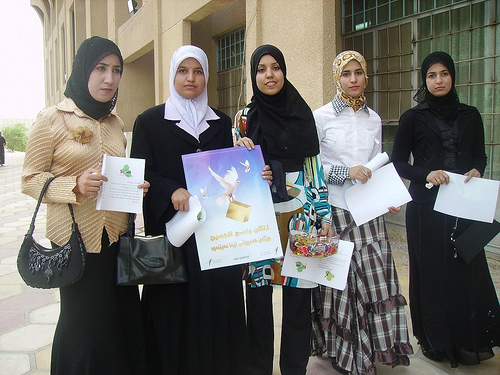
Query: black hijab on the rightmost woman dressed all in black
xmin=413 ymin=51 xmax=460 ymax=122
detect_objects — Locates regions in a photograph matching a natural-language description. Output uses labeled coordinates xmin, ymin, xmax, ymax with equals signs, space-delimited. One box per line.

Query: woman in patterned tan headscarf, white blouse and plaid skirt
xmin=313 ymin=51 xmax=413 ymax=374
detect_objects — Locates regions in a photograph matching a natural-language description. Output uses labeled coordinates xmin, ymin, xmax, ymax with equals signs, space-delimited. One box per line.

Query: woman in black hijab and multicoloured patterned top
xmin=235 ymin=45 xmax=333 ymax=375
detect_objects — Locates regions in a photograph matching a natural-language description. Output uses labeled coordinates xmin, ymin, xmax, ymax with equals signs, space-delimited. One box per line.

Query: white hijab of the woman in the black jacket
xmin=165 ymin=45 xmax=219 ymax=139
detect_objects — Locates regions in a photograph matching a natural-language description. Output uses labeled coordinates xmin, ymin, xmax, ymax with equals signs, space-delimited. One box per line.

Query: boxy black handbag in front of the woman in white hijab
xmin=116 ymin=214 xmax=188 ymax=285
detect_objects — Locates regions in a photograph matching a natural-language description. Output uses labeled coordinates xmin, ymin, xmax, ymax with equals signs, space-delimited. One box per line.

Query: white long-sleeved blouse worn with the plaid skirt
xmin=313 ymin=102 xmax=382 ymax=210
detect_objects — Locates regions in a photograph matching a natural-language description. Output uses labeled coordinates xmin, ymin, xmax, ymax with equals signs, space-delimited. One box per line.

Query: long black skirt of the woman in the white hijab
xmin=142 ymin=237 xmax=247 ymax=375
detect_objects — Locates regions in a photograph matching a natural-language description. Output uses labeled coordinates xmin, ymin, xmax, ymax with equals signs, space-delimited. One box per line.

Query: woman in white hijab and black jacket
xmin=131 ymin=46 xmax=252 ymax=375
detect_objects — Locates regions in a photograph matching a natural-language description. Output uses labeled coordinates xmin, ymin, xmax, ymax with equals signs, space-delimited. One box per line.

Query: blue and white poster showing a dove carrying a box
xmin=182 ymin=146 xmax=282 ymax=270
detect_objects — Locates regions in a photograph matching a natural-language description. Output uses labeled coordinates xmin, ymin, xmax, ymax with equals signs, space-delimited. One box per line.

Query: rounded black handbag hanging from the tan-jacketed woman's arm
xmin=17 ymin=177 xmax=87 ymax=289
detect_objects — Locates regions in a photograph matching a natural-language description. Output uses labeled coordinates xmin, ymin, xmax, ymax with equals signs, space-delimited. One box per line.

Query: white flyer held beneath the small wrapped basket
xmin=281 ymin=240 xmax=354 ymax=290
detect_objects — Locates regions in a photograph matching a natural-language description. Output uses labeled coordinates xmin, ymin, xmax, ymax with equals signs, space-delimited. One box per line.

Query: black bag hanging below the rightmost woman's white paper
xmin=451 ymin=219 xmax=500 ymax=264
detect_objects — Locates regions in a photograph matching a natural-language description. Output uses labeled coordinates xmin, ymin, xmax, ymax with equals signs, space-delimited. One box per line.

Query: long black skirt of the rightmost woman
xmin=406 ymin=201 xmax=500 ymax=364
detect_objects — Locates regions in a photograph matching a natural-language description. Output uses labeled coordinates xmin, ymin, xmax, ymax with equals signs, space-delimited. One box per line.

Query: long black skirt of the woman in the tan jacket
xmin=50 ymin=234 xmax=146 ymax=375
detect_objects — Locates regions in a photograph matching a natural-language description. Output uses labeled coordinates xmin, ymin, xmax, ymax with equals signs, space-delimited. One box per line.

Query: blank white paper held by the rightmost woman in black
xmin=434 ymin=171 xmax=500 ymax=223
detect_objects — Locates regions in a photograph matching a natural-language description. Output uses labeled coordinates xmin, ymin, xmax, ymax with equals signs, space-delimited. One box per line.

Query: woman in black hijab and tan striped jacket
xmin=22 ymin=36 xmax=149 ymax=375
